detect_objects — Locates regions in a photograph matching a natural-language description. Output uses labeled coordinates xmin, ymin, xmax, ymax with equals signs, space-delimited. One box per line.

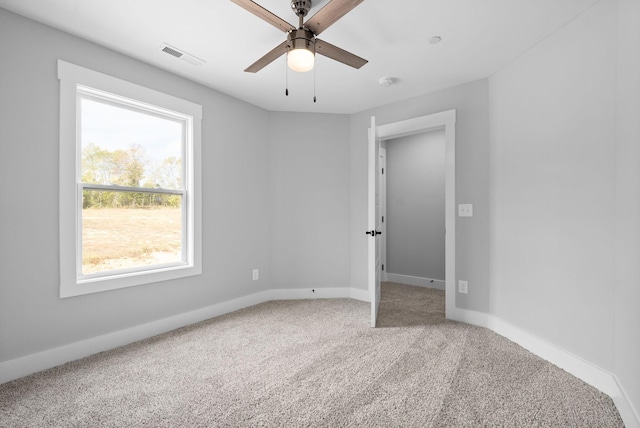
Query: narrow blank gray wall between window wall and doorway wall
xmin=269 ymin=112 xmax=350 ymax=288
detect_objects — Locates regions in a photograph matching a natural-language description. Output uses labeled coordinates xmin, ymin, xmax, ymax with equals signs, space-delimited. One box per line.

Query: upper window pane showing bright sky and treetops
xmin=80 ymin=96 xmax=185 ymax=189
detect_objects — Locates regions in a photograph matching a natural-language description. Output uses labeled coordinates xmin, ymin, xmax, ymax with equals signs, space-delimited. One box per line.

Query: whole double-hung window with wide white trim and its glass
xmin=58 ymin=61 xmax=202 ymax=297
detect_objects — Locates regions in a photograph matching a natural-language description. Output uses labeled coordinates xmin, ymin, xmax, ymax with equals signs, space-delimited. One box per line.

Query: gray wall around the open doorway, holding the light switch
xmin=350 ymin=79 xmax=489 ymax=312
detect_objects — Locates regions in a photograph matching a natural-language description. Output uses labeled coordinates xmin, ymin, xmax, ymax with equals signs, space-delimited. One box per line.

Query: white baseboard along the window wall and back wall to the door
xmin=0 ymin=287 xmax=369 ymax=384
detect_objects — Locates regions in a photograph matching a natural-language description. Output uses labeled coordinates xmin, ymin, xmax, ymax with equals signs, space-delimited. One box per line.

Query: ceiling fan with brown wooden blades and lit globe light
xmin=231 ymin=0 xmax=368 ymax=73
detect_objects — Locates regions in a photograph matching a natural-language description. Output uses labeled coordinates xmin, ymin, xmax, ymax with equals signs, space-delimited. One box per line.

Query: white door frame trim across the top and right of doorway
xmin=376 ymin=110 xmax=456 ymax=318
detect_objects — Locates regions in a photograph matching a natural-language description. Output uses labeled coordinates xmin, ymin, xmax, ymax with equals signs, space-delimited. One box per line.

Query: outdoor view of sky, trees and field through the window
xmin=78 ymin=88 xmax=187 ymax=276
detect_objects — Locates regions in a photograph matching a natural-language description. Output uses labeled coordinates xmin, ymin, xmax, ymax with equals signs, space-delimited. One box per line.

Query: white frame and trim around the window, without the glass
xmin=58 ymin=60 xmax=202 ymax=298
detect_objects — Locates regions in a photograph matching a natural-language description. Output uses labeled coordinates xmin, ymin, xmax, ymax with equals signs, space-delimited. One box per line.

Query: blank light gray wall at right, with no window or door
xmin=490 ymin=0 xmax=640 ymax=410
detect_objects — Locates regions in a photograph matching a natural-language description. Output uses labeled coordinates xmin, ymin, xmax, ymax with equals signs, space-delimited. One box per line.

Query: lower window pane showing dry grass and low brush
xmin=82 ymin=190 xmax=183 ymax=275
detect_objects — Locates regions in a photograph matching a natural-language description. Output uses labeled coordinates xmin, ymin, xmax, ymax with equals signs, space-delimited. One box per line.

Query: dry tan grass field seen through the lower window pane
xmin=82 ymin=208 xmax=181 ymax=275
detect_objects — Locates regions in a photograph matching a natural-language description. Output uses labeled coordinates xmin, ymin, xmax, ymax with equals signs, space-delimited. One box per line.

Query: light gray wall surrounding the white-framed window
xmin=0 ymin=9 xmax=270 ymax=361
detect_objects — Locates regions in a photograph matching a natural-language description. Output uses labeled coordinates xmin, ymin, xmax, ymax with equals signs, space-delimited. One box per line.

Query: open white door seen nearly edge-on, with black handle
xmin=366 ymin=116 xmax=381 ymax=327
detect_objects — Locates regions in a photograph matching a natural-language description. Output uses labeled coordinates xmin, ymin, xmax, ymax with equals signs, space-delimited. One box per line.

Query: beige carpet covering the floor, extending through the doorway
xmin=0 ymin=283 xmax=623 ymax=428
